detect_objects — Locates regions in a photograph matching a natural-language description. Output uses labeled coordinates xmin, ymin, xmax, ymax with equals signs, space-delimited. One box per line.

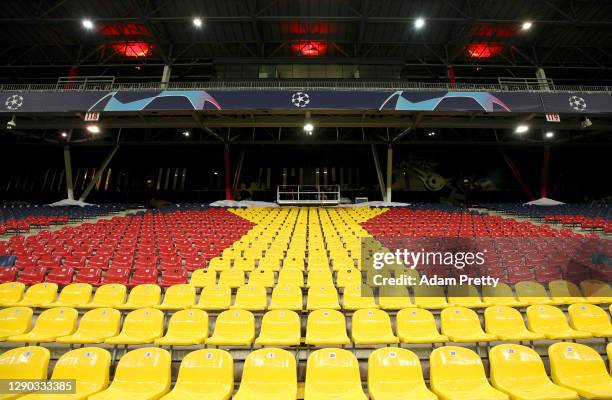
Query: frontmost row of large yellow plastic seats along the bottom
xmin=0 ymin=342 xmax=612 ymax=400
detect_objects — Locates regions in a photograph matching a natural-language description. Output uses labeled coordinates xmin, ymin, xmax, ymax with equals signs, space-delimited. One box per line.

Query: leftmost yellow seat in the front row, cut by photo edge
xmin=0 ymin=346 xmax=51 ymax=400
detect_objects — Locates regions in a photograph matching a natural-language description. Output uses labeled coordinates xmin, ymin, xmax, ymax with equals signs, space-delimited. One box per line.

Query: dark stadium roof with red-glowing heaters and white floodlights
xmin=0 ymin=0 xmax=612 ymax=84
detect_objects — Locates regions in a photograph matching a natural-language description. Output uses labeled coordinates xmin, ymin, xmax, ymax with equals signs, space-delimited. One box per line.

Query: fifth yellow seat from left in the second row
xmin=155 ymin=309 xmax=208 ymax=346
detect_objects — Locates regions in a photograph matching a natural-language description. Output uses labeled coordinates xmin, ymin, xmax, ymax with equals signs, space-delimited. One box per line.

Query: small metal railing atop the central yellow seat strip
xmin=276 ymin=185 xmax=340 ymax=205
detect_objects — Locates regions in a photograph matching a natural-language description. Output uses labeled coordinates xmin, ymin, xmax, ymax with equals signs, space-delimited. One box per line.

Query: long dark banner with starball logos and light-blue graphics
xmin=0 ymin=90 xmax=612 ymax=114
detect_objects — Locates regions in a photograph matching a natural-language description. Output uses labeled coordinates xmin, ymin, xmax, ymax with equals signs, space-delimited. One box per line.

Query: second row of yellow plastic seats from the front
xmin=0 ymin=304 xmax=612 ymax=346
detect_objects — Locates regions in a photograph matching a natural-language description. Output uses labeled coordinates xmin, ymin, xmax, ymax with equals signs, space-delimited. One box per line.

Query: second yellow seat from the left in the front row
xmin=20 ymin=347 xmax=111 ymax=400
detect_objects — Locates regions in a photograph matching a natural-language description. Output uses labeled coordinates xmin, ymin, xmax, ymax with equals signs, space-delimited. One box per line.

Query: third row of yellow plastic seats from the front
xmin=0 ymin=281 xmax=612 ymax=311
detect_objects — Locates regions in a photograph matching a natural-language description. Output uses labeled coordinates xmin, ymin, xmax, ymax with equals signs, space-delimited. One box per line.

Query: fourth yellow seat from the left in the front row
xmin=161 ymin=349 xmax=234 ymax=400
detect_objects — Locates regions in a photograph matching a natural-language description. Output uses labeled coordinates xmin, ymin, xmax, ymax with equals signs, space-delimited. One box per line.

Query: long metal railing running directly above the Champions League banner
xmin=0 ymin=77 xmax=612 ymax=95
